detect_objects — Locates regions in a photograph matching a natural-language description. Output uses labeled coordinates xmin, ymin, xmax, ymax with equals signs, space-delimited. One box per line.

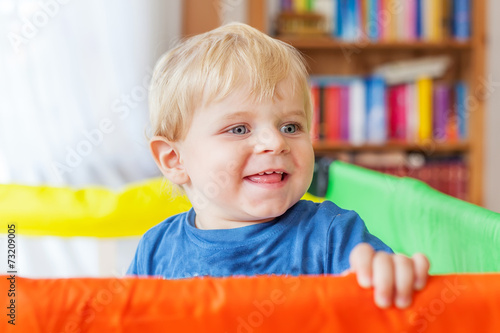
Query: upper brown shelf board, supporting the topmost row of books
xmin=278 ymin=35 xmax=472 ymax=51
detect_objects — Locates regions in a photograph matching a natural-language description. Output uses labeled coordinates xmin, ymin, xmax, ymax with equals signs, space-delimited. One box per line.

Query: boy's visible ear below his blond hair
xmin=149 ymin=136 xmax=189 ymax=185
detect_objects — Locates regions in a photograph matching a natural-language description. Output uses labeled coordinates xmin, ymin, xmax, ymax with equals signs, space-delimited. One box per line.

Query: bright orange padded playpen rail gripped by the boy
xmin=0 ymin=274 xmax=500 ymax=333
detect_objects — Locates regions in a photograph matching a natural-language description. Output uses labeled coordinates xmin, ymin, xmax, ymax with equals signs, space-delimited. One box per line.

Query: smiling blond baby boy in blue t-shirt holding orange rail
xmin=128 ymin=24 xmax=429 ymax=308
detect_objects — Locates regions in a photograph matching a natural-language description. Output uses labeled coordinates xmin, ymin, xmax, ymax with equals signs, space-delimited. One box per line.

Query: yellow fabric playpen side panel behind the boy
xmin=0 ymin=178 xmax=321 ymax=237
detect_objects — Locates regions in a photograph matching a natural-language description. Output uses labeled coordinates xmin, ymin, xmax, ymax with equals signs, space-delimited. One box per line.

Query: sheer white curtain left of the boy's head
xmin=0 ymin=0 xmax=181 ymax=188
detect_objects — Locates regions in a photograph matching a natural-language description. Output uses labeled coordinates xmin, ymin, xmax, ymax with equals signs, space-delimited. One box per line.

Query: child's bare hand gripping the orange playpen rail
xmin=349 ymin=243 xmax=429 ymax=308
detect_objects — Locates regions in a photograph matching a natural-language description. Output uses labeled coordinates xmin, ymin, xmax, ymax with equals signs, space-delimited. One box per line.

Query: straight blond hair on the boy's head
xmin=149 ymin=23 xmax=312 ymax=141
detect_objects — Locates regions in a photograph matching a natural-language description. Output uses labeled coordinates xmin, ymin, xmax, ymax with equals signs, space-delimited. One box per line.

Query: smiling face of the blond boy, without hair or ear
xmin=178 ymin=83 xmax=314 ymax=229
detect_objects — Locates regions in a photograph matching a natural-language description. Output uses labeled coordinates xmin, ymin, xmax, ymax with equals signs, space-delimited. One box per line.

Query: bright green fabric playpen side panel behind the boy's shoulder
xmin=326 ymin=161 xmax=500 ymax=274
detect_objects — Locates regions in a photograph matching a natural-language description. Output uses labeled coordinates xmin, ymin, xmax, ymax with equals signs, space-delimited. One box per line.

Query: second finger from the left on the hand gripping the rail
xmin=373 ymin=251 xmax=394 ymax=308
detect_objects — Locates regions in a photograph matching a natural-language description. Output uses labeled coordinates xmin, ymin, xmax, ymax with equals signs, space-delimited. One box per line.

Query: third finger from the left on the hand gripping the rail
xmin=392 ymin=254 xmax=415 ymax=309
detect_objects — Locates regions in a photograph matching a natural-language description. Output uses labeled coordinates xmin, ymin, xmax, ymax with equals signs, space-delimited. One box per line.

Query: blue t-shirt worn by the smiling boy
xmin=127 ymin=200 xmax=392 ymax=279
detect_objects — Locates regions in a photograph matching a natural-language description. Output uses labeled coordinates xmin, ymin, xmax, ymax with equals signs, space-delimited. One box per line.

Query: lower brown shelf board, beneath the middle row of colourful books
xmin=313 ymin=141 xmax=470 ymax=154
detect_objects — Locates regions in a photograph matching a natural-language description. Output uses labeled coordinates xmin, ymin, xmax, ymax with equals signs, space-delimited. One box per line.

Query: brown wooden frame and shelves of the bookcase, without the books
xmin=247 ymin=0 xmax=489 ymax=205
